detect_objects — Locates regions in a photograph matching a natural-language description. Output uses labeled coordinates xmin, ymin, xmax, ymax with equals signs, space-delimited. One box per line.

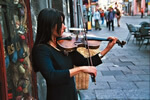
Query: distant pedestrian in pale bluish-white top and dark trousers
xmin=93 ymin=9 xmax=101 ymax=30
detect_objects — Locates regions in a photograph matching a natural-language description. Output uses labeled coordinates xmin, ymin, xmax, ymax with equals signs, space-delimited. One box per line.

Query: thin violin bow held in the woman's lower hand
xmin=78 ymin=3 xmax=96 ymax=85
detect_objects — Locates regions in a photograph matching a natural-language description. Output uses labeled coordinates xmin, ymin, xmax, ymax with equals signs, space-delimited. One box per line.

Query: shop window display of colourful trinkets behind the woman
xmin=0 ymin=0 xmax=34 ymax=100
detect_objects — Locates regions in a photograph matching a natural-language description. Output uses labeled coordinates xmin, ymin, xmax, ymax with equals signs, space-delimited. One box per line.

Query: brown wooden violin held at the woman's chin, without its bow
xmin=57 ymin=32 xmax=126 ymax=52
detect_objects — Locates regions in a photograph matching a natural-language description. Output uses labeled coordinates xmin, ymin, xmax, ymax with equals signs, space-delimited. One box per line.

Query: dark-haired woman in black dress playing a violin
xmin=32 ymin=8 xmax=117 ymax=100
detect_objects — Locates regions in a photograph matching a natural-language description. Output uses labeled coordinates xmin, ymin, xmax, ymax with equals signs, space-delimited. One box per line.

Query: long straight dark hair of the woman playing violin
xmin=34 ymin=8 xmax=65 ymax=46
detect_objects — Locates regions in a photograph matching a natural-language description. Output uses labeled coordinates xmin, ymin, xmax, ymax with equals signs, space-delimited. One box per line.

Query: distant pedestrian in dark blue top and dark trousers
xmin=108 ymin=7 xmax=115 ymax=31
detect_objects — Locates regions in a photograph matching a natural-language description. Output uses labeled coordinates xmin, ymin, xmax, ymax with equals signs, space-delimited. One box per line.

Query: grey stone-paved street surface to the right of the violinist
xmin=79 ymin=16 xmax=150 ymax=100
